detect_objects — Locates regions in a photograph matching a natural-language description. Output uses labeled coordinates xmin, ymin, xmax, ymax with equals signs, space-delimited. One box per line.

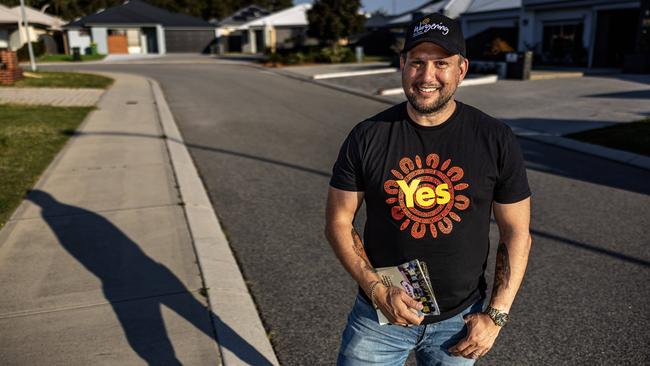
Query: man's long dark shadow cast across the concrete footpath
xmin=27 ymin=190 xmax=271 ymax=365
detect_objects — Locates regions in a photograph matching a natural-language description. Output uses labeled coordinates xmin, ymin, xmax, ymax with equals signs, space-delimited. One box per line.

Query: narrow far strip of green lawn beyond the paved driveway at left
xmin=13 ymin=71 xmax=113 ymax=89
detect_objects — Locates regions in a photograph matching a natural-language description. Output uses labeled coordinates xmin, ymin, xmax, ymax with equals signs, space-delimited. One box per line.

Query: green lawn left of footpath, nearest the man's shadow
xmin=0 ymin=104 xmax=93 ymax=228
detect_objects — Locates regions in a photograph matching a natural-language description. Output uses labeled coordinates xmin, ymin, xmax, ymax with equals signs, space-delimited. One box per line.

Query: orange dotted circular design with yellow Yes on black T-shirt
xmin=384 ymin=154 xmax=470 ymax=239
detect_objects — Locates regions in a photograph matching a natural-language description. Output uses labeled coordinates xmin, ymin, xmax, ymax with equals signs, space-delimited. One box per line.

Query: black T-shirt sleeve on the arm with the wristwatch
xmin=494 ymin=128 xmax=531 ymax=204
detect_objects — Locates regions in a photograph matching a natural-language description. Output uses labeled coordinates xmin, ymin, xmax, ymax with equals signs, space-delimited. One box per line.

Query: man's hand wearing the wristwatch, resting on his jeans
xmin=449 ymin=313 xmax=501 ymax=359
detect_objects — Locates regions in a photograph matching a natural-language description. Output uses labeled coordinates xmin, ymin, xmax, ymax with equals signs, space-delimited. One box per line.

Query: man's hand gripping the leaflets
xmin=372 ymin=285 xmax=424 ymax=326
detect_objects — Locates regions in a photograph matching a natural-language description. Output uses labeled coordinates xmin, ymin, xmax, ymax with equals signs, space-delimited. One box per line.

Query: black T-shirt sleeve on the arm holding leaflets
xmin=330 ymin=129 xmax=365 ymax=192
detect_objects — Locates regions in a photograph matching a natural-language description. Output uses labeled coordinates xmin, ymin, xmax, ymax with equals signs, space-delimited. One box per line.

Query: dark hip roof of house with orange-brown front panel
xmin=65 ymin=0 xmax=214 ymax=28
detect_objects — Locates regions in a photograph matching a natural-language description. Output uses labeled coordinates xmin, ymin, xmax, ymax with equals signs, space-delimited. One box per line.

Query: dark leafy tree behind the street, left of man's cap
xmin=307 ymin=0 xmax=366 ymax=44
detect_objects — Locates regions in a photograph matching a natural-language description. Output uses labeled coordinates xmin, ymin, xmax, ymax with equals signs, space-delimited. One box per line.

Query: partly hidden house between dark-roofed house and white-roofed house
xmin=216 ymin=5 xmax=271 ymax=53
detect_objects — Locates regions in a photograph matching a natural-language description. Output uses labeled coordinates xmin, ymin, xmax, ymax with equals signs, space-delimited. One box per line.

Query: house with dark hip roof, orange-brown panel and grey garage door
xmin=64 ymin=0 xmax=216 ymax=54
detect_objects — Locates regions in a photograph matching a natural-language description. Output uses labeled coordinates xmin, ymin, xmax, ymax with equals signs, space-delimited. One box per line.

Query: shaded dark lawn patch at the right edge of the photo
xmin=566 ymin=118 xmax=650 ymax=156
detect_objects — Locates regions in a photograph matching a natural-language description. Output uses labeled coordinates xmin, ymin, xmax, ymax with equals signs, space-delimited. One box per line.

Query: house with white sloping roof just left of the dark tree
xmin=237 ymin=4 xmax=311 ymax=53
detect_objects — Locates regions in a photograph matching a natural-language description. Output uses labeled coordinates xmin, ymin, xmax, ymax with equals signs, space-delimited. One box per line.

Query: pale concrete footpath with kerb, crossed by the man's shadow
xmin=0 ymin=74 xmax=278 ymax=365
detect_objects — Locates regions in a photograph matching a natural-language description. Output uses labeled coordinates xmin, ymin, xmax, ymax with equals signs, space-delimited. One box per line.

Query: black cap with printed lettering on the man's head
xmin=402 ymin=13 xmax=465 ymax=57
